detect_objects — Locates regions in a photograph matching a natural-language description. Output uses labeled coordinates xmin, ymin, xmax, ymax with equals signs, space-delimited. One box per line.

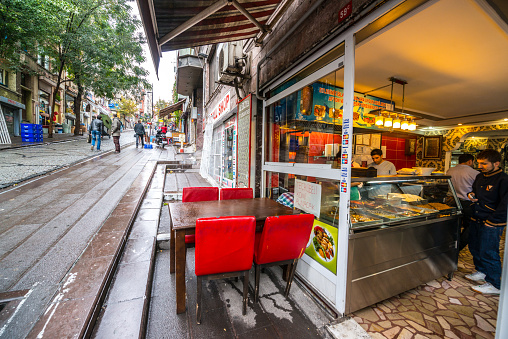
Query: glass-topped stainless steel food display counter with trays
xmin=295 ymin=175 xmax=461 ymax=314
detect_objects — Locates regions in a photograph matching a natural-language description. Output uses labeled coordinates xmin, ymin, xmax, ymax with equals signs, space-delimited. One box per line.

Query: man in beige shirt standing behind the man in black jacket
xmin=446 ymin=154 xmax=480 ymax=251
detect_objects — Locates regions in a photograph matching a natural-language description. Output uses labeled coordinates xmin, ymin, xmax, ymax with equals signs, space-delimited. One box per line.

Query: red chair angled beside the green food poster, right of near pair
xmin=254 ymin=214 xmax=314 ymax=302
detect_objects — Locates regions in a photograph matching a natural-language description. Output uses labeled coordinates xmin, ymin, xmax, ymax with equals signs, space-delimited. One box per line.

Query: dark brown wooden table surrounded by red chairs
xmin=168 ymin=198 xmax=296 ymax=313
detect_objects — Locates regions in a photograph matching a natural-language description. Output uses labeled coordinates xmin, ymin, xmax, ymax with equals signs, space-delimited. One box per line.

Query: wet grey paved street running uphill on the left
xmin=0 ymin=142 xmax=174 ymax=338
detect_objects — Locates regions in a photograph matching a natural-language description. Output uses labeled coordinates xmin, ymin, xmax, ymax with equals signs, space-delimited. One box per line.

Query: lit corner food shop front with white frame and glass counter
xmin=258 ymin=0 xmax=508 ymax=314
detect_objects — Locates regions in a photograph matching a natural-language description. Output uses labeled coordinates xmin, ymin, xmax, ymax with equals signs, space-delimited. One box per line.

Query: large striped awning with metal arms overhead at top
xmin=137 ymin=0 xmax=293 ymax=75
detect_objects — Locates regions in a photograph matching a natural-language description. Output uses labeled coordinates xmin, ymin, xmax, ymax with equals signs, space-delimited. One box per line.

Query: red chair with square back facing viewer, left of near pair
xmin=195 ymin=216 xmax=256 ymax=324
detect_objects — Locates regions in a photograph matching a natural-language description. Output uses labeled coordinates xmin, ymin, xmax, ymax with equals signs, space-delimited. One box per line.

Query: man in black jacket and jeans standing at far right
xmin=465 ymin=149 xmax=508 ymax=294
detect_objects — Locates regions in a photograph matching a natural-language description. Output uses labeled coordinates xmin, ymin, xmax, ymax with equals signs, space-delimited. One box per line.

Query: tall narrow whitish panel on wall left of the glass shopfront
xmin=236 ymin=95 xmax=252 ymax=187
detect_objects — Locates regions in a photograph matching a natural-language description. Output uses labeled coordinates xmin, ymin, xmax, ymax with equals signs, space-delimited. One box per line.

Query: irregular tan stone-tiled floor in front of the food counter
xmin=352 ymin=232 xmax=506 ymax=339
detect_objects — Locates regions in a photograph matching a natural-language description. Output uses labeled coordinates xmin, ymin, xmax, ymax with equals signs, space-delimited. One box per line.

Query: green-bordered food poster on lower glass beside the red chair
xmin=305 ymin=220 xmax=338 ymax=274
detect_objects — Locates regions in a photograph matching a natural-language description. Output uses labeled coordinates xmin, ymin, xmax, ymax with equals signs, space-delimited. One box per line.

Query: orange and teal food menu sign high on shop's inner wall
xmin=296 ymin=82 xmax=392 ymax=129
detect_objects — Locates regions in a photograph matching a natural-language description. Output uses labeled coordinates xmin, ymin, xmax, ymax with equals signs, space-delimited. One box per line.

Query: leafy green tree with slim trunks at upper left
xmin=0 ymin=0 xmax=149 ymax=137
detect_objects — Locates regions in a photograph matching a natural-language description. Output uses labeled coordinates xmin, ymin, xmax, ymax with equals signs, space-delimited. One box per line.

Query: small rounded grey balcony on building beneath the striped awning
xmin=176 ymin=48 xmax=204 ymax=96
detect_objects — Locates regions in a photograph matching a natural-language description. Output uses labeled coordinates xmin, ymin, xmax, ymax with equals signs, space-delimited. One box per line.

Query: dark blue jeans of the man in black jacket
xmin=469 ymin=220 xmax=504 ymax=289
